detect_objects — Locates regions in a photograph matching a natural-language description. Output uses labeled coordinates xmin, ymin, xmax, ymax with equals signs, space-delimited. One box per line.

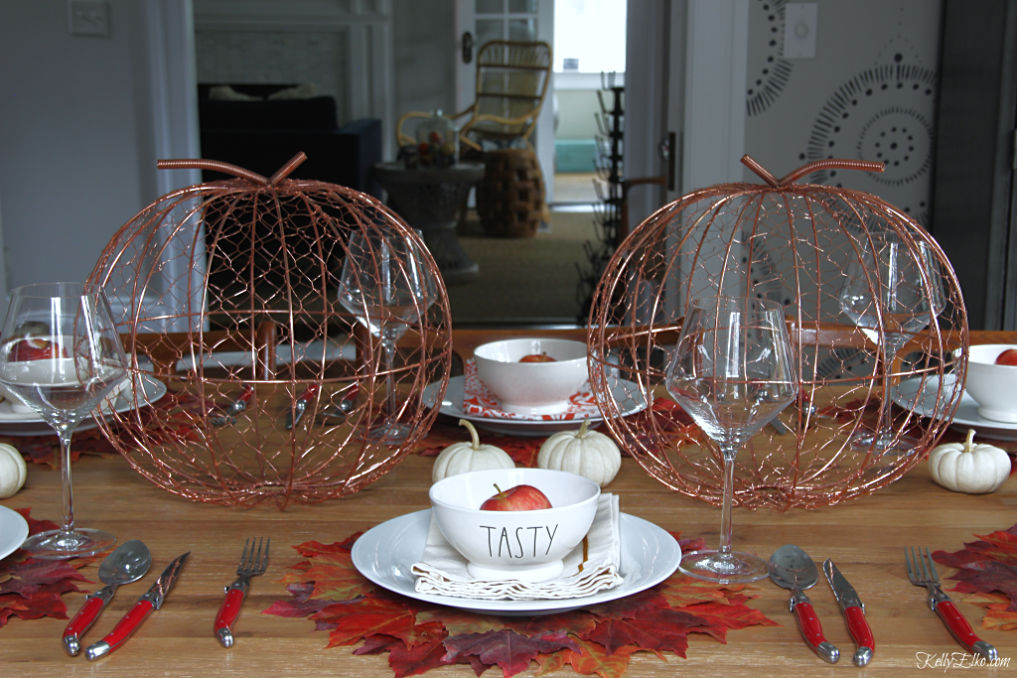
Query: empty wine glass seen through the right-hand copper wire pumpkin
xmin=840 ymin=233 xmax=944 ymax=455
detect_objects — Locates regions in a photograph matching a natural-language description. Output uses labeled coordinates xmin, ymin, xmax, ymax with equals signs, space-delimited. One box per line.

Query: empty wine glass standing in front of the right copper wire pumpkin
xmin=664 ymin=296 xmax=798 ymax=583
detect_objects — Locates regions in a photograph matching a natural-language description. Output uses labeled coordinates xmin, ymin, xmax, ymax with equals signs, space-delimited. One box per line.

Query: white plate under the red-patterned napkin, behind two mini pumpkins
xmin=424 ymin=375 xmax=646 ymax=436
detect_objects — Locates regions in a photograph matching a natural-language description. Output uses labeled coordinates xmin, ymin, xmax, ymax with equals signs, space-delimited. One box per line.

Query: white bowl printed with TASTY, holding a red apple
xmin=429 ymin=468 xmax=600 ymax=581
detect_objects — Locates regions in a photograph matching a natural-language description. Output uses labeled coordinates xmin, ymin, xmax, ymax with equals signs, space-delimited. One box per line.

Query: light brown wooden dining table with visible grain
xmin=0 ymin=329 xmax=1017 ymax=678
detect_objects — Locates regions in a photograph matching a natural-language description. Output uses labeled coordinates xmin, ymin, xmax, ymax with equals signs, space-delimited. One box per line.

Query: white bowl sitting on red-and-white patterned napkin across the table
xmin=473 ymin=337 xmax=590 ymax=416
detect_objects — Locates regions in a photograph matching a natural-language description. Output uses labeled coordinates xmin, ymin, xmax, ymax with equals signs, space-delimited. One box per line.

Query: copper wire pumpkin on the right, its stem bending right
xmin=588 ymin=157 xmax=968 ymax=509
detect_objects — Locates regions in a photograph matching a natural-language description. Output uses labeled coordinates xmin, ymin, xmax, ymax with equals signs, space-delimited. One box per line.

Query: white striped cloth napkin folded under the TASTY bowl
xmin=411 ymin=493 xmax=623 ymax=601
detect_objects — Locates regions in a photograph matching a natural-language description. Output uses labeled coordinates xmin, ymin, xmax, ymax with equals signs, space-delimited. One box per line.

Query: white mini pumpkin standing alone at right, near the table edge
xmin=929 ymin=429 xmax=1010 ymax=494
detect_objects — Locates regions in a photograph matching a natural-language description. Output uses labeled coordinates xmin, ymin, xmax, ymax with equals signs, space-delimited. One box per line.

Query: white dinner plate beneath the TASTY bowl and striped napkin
xmin=352 ymin=508 xmax=681 ymax=615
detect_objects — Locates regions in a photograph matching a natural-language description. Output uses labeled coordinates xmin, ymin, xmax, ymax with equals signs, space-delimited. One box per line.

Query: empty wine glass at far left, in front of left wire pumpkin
xmin=0 ymin=283 xmax=127 ymax=558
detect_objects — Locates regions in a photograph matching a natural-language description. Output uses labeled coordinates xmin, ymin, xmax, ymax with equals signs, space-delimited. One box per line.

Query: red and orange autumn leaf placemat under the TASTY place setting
xmin=264 ymin=533 xmax=776 ymax=678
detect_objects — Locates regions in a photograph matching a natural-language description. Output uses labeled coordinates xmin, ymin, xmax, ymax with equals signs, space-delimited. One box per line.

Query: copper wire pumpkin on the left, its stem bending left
xmin=92 ymin=153 xmax=452 ymax=508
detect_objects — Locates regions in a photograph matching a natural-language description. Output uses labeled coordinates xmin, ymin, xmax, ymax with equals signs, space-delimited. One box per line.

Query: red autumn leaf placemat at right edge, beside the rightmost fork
xmin=933 ymin=525 xmax=1017 ymax=631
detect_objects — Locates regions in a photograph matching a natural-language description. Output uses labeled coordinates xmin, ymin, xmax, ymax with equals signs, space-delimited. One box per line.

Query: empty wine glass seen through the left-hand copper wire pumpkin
xmin=339 ymin=229 xmax=438 ymax=444
